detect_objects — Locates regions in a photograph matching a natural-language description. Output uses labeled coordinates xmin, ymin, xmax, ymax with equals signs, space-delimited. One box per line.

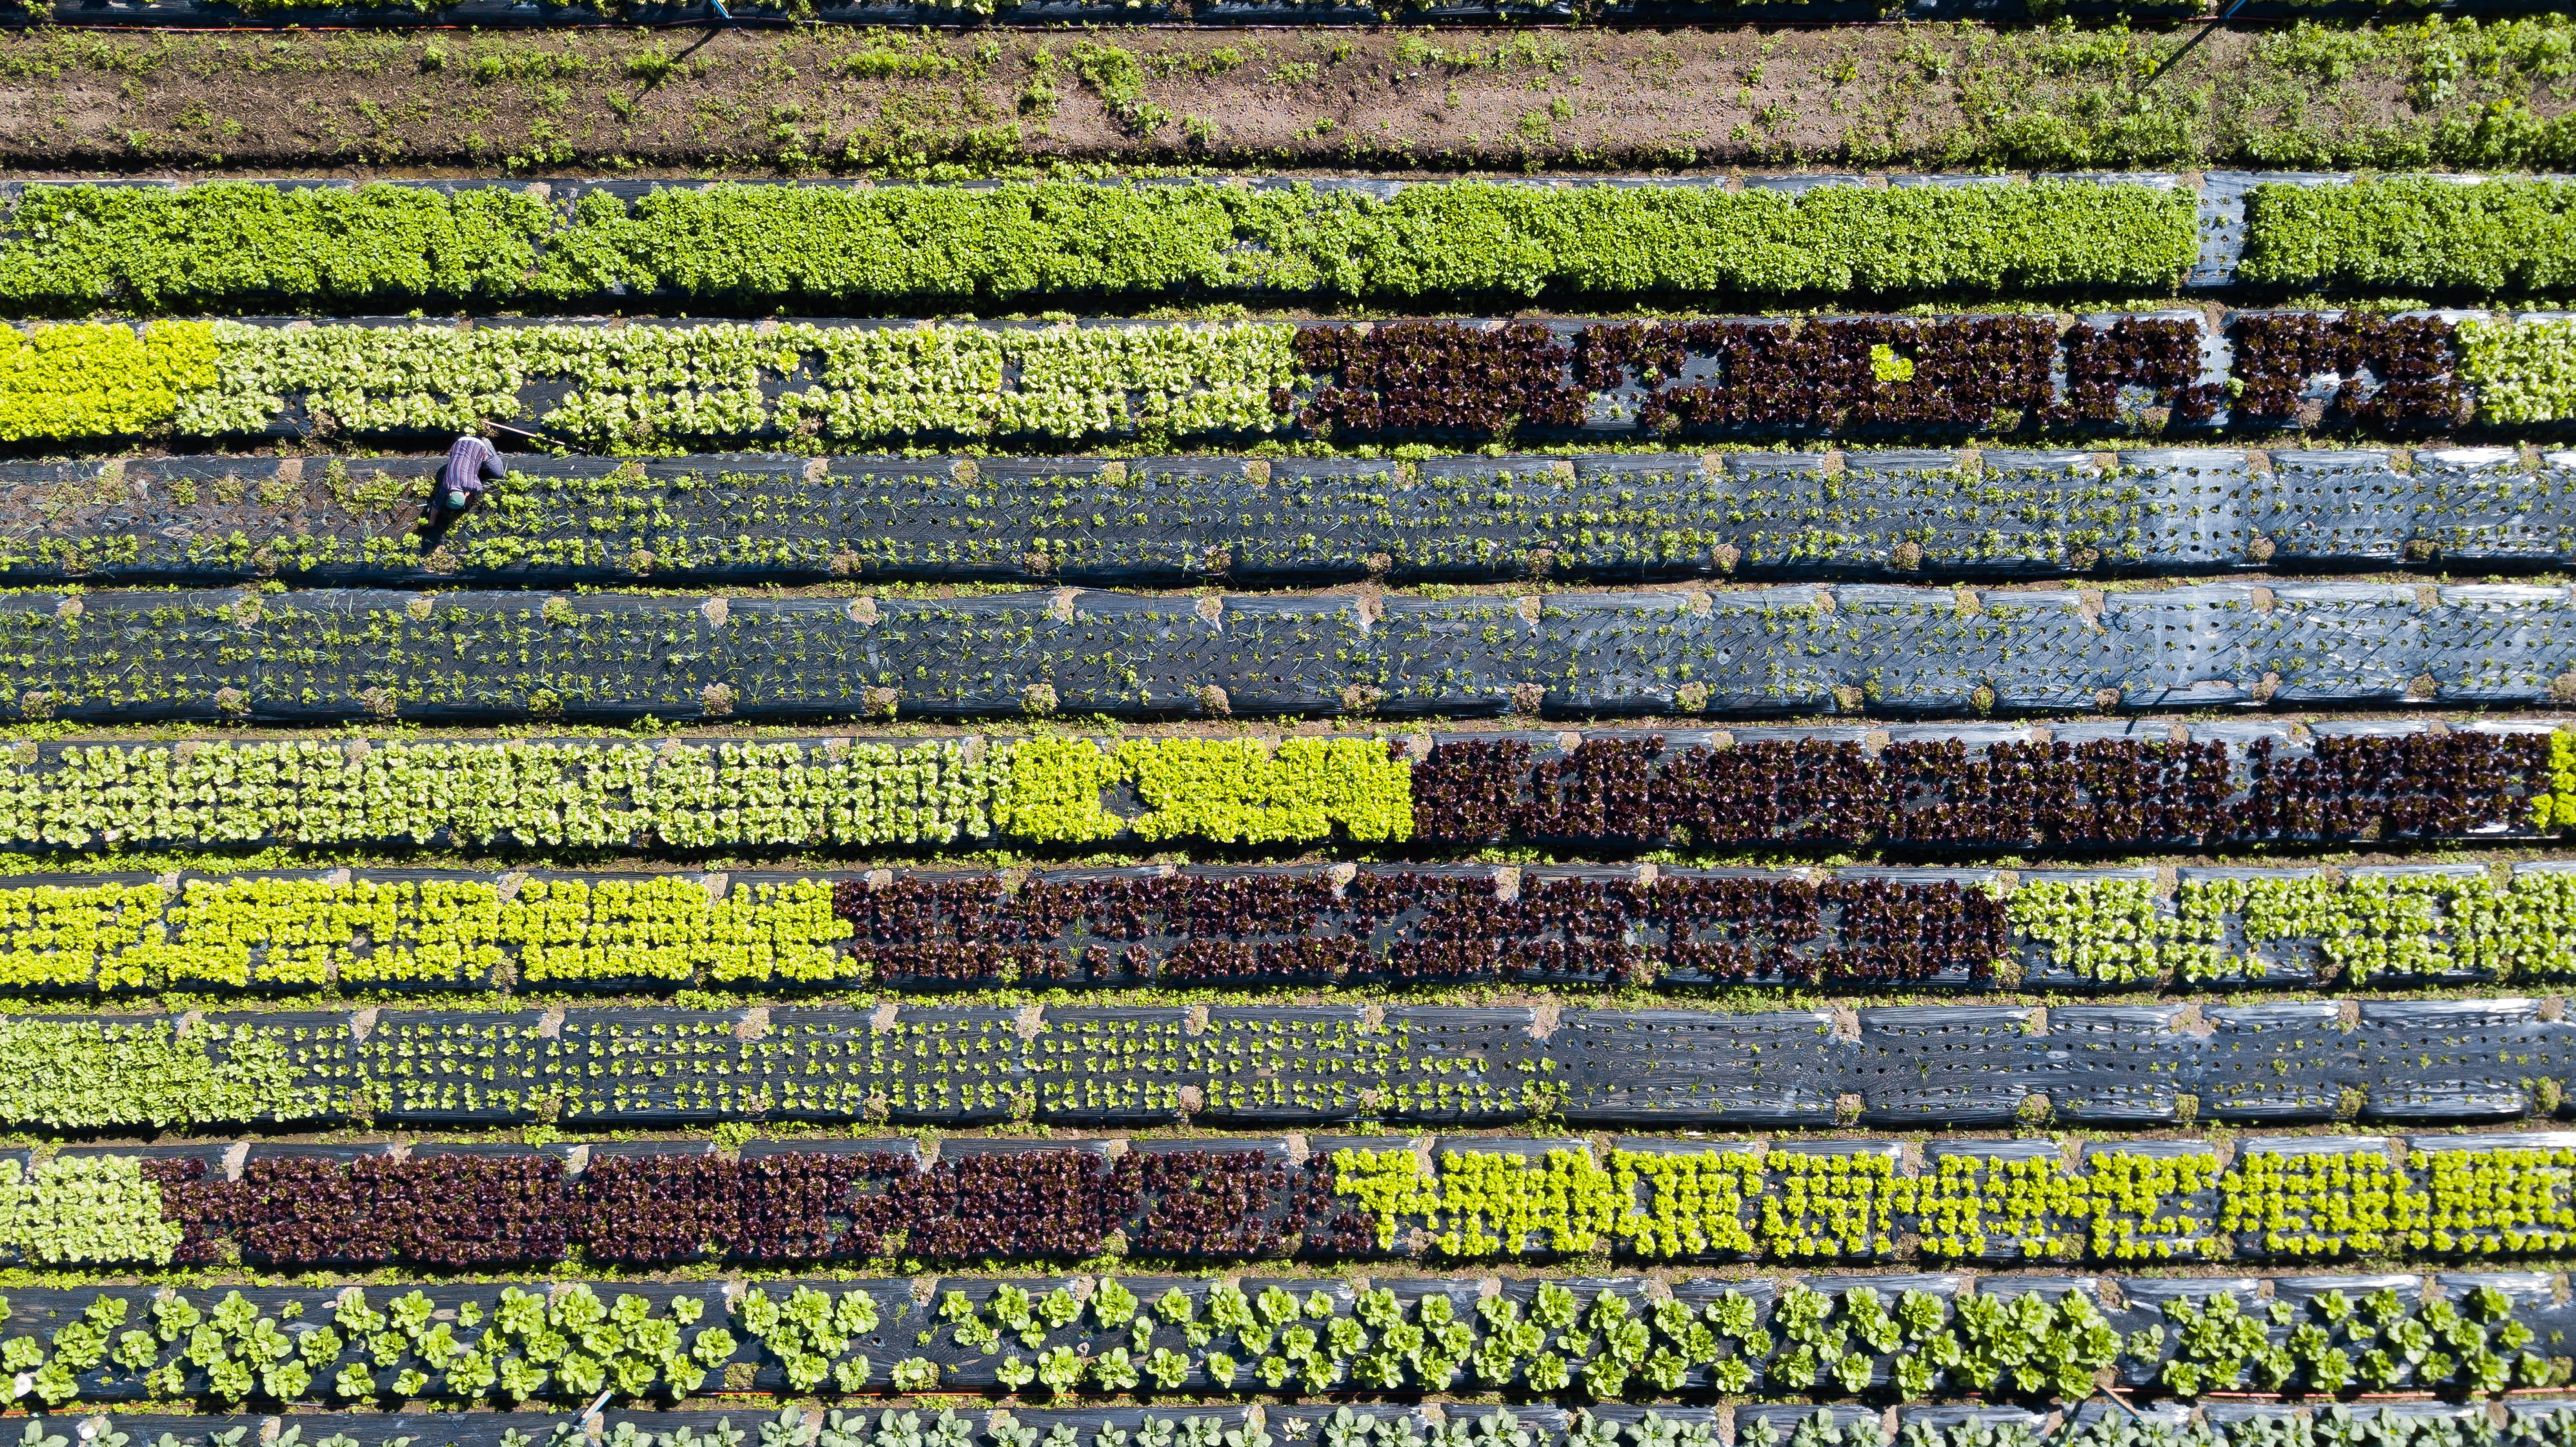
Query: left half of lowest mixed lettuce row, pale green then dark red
xmin=0 ymin=1140 xmax=1288 ymax=1272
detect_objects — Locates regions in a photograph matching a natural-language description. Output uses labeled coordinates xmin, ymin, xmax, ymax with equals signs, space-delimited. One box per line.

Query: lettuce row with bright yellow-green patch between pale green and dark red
xmin=0 ymin=721 xmax=2535 ymax=852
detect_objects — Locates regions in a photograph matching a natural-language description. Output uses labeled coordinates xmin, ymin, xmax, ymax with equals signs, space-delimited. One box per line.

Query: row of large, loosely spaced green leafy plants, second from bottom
xmin=0 ymin=1256 xmax=2568 ymax=1401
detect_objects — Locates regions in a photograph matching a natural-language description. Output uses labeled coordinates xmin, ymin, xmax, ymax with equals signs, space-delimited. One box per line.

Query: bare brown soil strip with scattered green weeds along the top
xmin=0 ymin=21 xmax=2535 ymax=177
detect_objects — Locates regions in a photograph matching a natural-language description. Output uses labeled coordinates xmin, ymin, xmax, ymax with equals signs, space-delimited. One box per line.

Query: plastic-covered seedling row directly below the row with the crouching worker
xmin=0 ymin=585 xmax=2576 ymax=721
